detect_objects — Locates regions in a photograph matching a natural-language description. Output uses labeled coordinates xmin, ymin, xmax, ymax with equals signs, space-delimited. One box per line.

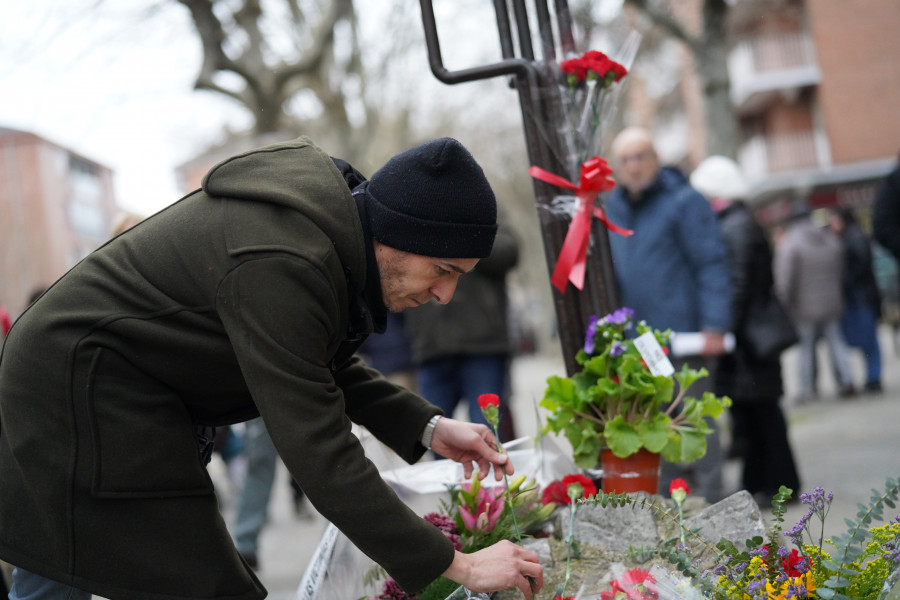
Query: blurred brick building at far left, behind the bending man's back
xmin=0 ymin=127 xmax=118 ymax=317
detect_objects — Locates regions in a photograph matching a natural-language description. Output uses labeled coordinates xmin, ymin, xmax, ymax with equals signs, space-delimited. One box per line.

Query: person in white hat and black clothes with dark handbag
xmin=690 ymin=155 xmax=800 ymax=506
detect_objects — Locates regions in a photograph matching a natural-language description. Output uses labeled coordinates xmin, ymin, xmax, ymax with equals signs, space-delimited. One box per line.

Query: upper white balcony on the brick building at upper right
xmin=728 ymin=32 xmax=822 ymax=108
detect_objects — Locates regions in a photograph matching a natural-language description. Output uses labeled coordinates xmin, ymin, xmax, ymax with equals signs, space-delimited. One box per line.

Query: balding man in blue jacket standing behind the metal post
xmin=606 ymin=127 xmax=731 ymax=502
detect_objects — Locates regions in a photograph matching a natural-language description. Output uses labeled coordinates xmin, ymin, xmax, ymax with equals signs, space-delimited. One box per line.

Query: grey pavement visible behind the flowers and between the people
xmin=223 ymin=328 xmax=900 ymax=600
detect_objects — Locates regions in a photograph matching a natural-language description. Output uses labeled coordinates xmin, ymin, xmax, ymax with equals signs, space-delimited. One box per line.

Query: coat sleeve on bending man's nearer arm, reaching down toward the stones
xmin=217 ymin=254 xmax=454 ymax=592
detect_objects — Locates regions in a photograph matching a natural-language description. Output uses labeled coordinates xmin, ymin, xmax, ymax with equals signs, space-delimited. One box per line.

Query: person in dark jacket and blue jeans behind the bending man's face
xmin=404 ymin=216 xmax=519 ymax=442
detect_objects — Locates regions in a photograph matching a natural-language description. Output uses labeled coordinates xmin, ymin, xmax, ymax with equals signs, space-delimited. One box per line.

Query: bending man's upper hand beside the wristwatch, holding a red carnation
xmin=431 ymin=417 xmax=514 ymax=481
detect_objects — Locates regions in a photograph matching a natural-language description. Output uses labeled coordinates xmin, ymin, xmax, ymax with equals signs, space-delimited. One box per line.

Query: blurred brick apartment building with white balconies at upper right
xmin=632 ymin=0 xmax=900 ymax=226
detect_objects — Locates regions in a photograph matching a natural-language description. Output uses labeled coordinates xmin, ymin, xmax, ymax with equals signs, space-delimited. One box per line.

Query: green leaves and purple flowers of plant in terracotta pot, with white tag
xmin=540 ymin=308 xmax=731 ymax=469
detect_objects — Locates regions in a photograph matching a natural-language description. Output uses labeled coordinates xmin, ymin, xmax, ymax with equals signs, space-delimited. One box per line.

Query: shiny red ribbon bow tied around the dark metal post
xmin=528 ymin=156 xmax=634 ymax=293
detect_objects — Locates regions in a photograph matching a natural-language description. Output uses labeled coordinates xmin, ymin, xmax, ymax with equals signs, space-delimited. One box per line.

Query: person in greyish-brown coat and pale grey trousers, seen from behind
xmin=773 ymin=205 xmax=856 ymax=404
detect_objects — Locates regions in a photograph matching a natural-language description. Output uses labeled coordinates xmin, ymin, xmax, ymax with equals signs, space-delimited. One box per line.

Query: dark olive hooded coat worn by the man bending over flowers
xmin=0 ymin=138 xmax=453 ymax=600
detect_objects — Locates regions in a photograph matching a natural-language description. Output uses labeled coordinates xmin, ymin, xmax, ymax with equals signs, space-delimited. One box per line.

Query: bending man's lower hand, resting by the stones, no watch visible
xmin=441 ymin=540 xmax=544 ymax=600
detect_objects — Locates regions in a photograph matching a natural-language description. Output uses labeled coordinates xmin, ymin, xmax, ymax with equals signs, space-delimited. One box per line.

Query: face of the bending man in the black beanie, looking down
xmin=374 ymin=241 xmax=478 ymax=312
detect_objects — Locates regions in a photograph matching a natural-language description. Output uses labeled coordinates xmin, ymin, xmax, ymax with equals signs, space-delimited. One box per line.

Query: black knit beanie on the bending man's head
xmin=363 ymin=138 xmax=497 ymax=258
